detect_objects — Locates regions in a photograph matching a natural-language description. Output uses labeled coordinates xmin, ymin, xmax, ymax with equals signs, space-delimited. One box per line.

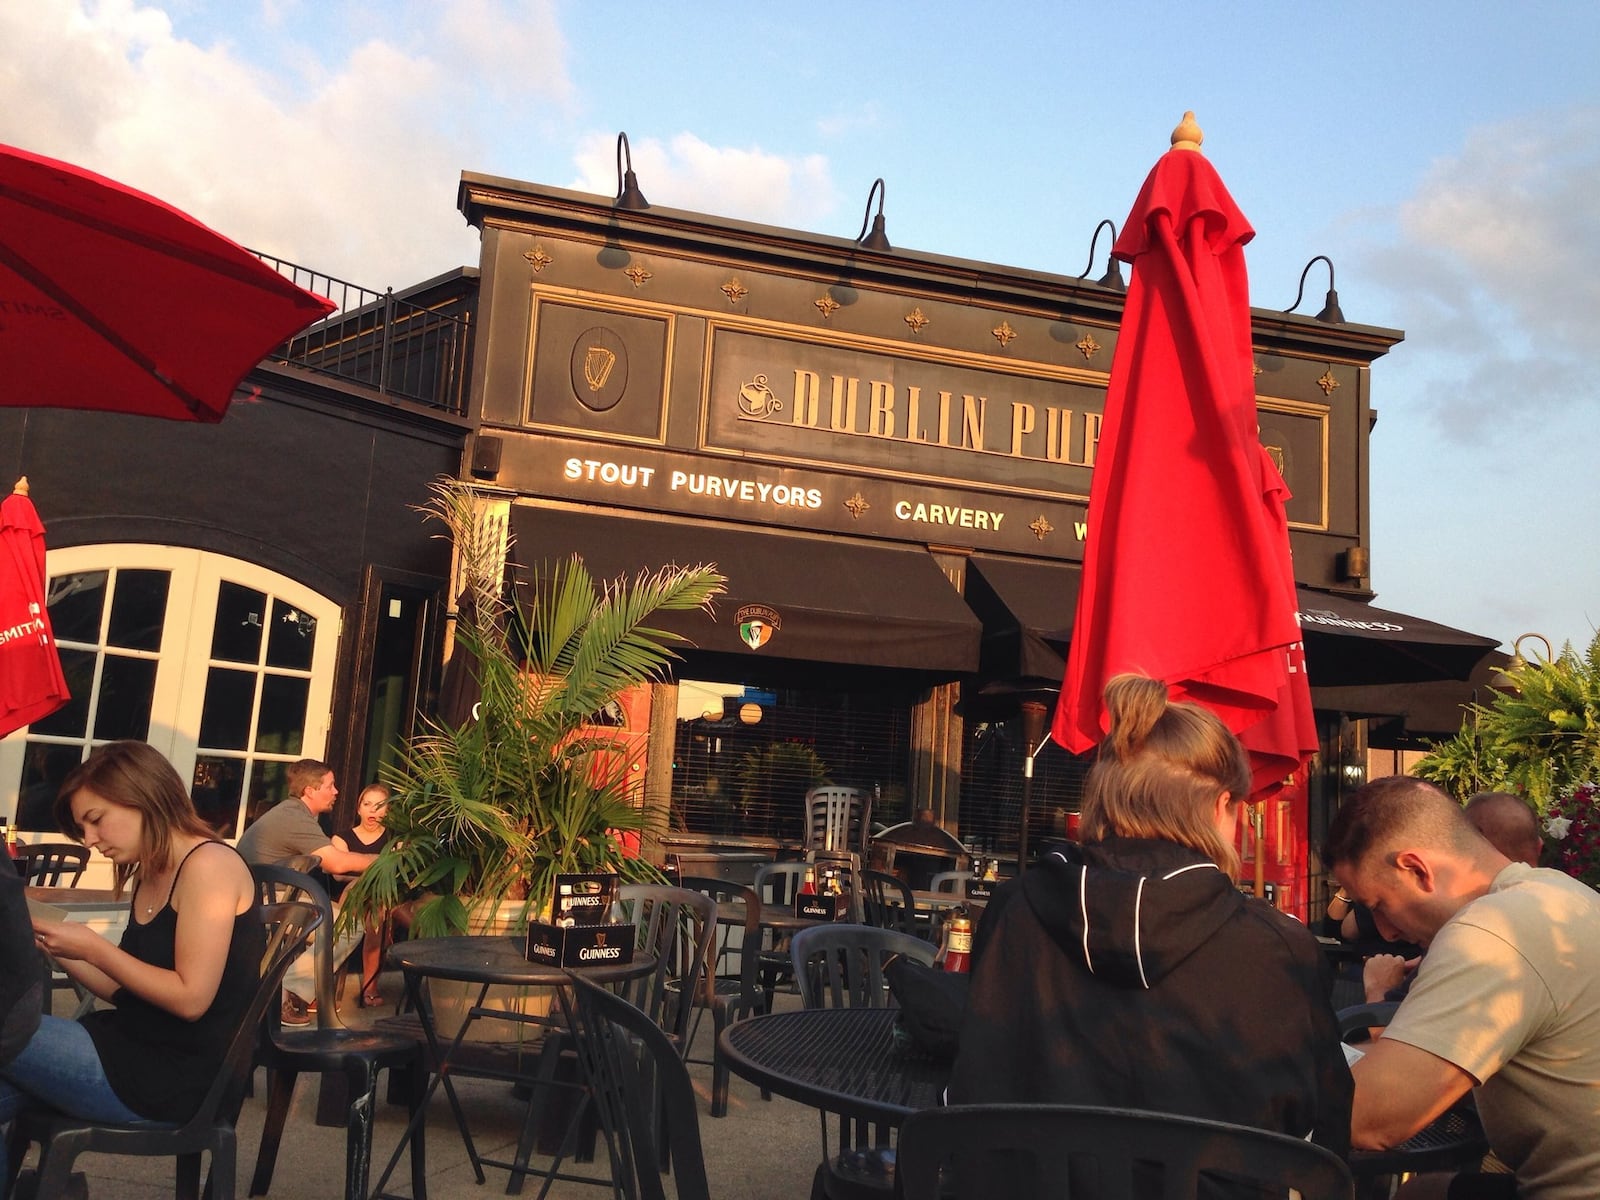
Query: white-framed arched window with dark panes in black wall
xmin=0 ymin=544 xmax=339 ymax=837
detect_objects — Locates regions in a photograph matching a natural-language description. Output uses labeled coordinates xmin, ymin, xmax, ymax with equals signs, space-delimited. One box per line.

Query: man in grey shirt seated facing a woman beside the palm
xmin=238 ymin=758 xmax=378 ymax=1026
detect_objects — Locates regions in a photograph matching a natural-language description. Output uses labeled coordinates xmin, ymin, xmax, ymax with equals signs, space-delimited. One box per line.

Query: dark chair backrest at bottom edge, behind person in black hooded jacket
xmin=896 ymin=1104 xmax=1355 ymax=1200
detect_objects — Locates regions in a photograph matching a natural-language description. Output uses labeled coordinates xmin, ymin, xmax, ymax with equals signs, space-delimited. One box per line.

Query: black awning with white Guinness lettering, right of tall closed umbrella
xmin=1296 ymin=587 xmax=1499 ymax=688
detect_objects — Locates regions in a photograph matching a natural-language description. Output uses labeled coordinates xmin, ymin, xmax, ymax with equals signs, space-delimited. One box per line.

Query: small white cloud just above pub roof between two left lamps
xmin=570 ymin=133 xmax=838 ymax=229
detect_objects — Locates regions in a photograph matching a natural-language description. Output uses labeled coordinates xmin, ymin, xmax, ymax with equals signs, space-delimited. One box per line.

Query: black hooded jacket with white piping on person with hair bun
xmin=949 ymin=838 xmax=1354 ymax=1155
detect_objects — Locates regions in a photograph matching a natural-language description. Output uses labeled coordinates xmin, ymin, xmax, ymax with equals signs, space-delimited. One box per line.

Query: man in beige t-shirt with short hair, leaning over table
xmin=1325 ymin=776 xmax=1600 ymax=1200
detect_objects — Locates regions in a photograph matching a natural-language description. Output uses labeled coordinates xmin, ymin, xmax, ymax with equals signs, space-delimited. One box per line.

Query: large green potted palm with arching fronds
xmin=341 ymin=480 xmax=723 ymax=936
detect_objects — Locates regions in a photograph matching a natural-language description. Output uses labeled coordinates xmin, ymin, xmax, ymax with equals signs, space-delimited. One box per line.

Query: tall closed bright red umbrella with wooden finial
xmin=1051 ymin=114 xmax=1317 ymax=797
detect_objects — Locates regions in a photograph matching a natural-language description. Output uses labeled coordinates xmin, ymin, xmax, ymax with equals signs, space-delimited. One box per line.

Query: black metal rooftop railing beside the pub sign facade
xmin=250 ymin=250 xmax=472 ymax=414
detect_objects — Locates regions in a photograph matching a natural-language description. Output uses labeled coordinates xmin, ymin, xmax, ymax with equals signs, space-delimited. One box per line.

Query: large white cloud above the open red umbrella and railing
xmin=0 ymin=0 xmax=571 ymax=288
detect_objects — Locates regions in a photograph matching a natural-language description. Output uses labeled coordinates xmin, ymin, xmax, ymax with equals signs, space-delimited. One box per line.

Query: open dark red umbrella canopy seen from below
xmin=0 ymin=146 xmax=333 ymax=421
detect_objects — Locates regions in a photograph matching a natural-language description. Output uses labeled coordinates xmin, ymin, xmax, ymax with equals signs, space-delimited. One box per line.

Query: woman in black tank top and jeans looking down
xmin=0 ymin=741 xmax=266 ymax=1179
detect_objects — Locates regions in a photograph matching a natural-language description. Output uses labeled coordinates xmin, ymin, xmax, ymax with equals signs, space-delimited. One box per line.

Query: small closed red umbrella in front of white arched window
xmin=0 ymin=477 xmax=69 ymax=738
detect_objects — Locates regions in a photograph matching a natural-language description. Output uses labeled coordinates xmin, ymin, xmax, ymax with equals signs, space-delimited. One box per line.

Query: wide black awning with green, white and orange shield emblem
xmin=510 ymin=504 xmax=981 ymax=677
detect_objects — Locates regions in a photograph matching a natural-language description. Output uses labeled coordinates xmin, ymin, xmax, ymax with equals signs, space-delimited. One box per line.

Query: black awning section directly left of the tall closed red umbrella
xmin=966 ymin=554 xmax=1083 ymax=688
